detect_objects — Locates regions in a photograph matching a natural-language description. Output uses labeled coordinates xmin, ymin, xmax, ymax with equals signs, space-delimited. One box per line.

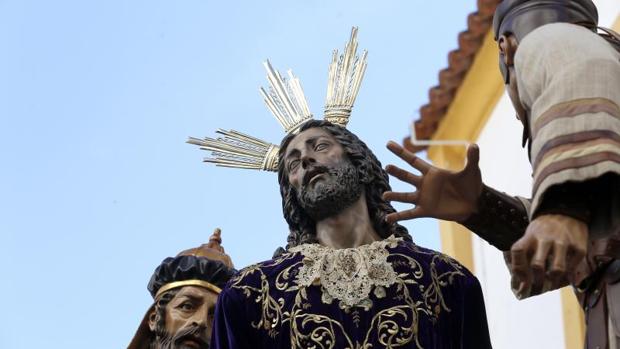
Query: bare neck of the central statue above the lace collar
xmin=316 ymin=194 xmax=381 ymax=249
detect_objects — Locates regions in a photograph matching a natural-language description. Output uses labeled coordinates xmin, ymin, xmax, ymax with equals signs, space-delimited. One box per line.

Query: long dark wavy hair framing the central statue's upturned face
xmin=278 ymin=120 xmax=412 ymax=249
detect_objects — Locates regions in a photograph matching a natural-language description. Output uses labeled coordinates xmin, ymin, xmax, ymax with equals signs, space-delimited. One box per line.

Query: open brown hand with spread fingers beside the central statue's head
xmin=383 ymin=142 xmax=482 ymax=222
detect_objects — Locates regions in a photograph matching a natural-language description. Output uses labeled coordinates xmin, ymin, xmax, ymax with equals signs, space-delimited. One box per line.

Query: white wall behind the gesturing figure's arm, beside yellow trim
xmin=473 ymin=95 xmax=565 ymax=349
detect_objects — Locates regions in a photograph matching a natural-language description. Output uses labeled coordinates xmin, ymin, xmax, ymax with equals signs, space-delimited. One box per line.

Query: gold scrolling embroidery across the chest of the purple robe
xmin=230 ymin=239 xmax=465 ymax=349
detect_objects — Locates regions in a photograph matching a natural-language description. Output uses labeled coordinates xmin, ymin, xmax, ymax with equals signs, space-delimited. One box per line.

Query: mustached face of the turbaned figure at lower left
xmin=149 ymin=286 xmax=217 ymax=349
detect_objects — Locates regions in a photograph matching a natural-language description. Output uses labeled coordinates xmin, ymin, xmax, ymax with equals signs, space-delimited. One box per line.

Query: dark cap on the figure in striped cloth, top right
xmin=493 ymin=0 xmax=598 ymax=41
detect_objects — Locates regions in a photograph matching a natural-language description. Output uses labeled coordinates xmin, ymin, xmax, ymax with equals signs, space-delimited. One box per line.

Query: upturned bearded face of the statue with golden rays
xmin=284 ymin=127 xmax=362 ymax=221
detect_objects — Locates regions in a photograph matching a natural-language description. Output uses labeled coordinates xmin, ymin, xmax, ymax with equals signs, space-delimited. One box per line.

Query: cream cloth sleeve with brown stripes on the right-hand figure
xmin=515 ymin=23 xmax=620 ymax=216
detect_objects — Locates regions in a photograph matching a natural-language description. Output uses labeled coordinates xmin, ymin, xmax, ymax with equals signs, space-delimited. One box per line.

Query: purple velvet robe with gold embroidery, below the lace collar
xmin=211 ymin=241 xmax=491 ymax=349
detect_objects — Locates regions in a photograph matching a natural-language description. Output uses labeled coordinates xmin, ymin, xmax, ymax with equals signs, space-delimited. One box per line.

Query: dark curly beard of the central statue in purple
xmin=297 ymin=161 xmax=362 ymax=222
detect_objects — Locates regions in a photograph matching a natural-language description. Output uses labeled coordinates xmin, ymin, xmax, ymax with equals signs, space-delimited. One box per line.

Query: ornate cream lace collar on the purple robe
xmin=289 ymin=235 xmax=402 ymax=309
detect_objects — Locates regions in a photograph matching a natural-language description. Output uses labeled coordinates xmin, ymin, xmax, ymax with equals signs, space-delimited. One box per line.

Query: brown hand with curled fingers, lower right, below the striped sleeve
xmin=506 ymin=214 xmax=588 ymax=298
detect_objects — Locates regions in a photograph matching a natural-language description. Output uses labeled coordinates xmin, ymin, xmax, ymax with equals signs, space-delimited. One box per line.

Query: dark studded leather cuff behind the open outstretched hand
xmin=460 ymin=185 xmax=529 ymax=251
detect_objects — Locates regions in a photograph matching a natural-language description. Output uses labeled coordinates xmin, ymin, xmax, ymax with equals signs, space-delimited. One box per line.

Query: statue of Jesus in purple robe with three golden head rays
xmin=191 ymin=29 xmax=491 ymax=349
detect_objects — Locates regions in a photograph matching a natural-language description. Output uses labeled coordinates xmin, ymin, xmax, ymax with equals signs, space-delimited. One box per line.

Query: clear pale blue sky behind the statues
xmin=0 ymin=0 xmax=476 ymax=349
